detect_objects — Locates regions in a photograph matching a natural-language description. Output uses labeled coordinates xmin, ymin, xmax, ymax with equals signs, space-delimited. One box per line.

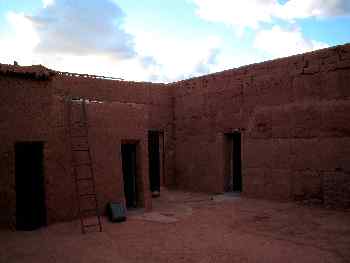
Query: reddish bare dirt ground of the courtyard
xmin=0 ymin=190 xmax=350 ymax=263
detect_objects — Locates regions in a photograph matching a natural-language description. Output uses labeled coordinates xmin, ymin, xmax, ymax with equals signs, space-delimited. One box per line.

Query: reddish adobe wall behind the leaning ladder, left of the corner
xmin=0 ymin=75 xmax=174 ymax=226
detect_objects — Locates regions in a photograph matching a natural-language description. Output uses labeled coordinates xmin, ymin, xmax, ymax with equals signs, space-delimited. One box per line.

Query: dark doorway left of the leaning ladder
xmin=15 ymin=142 xmax=46 ymax=230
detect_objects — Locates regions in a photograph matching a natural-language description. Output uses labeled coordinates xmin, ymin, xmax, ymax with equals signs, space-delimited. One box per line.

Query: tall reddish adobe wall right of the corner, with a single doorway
xmin=172 ymin=45 xmax=350 ymax=207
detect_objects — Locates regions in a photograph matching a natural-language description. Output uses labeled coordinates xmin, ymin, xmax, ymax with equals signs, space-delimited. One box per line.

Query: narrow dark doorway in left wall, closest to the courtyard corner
xmin=148 ymin=131 xmax=160 ymax=197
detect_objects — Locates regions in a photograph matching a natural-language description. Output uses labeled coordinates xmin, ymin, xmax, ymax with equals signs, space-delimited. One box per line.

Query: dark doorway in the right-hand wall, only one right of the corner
xmin=225 ymin=132 xmax=242 ymax=192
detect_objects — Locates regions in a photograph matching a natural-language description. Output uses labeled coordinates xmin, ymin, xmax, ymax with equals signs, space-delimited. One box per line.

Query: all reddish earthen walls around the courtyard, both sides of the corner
xmin=0 ymin=45 xmax=350 ymax=229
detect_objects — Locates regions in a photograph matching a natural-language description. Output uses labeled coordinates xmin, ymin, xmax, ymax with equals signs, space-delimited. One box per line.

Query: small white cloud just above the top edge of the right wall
xmin=254 ymin=26 xmax=328 ymax=58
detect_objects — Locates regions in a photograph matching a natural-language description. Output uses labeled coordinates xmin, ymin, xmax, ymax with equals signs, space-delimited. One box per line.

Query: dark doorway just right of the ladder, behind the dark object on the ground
xmin=121 ymin=143 xmax=138 ymax=208
